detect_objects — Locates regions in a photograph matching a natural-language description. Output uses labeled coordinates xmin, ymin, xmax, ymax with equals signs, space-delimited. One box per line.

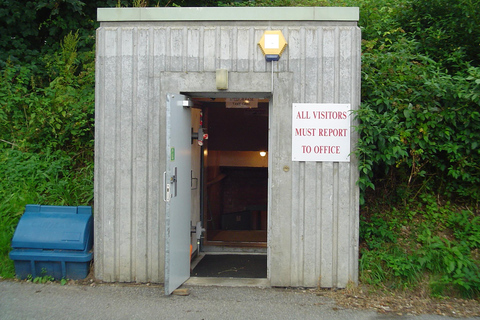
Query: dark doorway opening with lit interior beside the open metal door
xmin=191 ymin=97 xmax=269 ymax=278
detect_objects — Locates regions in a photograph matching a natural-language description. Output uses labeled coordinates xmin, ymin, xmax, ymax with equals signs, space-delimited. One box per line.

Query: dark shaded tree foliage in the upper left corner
xmin=0 ymin=0 xmax=119 ymax=66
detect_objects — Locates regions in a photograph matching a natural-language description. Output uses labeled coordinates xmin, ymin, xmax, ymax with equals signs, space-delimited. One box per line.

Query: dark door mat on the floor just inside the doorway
xmin=191 ymin=254 xmax=267 ymax=278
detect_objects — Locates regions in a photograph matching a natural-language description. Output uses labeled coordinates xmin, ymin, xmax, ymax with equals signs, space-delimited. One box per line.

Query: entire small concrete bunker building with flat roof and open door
xmin=94 ymin=7 xmax=361 ymax=293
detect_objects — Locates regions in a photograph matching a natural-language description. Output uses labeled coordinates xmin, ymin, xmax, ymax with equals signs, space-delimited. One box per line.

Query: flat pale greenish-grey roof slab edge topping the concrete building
xmin=97 ymin=7 xmax=360 ymax=22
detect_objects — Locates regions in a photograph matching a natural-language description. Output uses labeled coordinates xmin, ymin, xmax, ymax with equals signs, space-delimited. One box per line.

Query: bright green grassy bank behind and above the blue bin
xmin=0 ymin=149 xmax=93 ymax=278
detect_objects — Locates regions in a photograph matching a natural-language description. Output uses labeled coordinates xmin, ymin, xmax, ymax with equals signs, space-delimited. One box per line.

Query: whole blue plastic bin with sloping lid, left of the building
xmin=10 ymin=205 xmax=93 ymax=279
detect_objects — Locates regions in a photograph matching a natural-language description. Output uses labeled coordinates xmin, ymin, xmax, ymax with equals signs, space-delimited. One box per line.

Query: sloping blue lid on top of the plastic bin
xmin=12 ymin=205 xmax=93 ymax=251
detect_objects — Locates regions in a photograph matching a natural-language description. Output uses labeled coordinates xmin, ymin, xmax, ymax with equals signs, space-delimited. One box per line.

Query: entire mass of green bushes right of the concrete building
xmin=351 ymin=0 xmax=480 ymax=297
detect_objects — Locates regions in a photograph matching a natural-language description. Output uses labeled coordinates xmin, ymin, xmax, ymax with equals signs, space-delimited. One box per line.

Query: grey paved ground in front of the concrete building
xmin=0 ymin=281 xmax=478 ymax=320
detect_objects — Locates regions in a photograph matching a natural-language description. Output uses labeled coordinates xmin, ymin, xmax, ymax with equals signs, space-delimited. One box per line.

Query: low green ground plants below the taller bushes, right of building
xmin=360 ymin=195 xmax=480 ymax=298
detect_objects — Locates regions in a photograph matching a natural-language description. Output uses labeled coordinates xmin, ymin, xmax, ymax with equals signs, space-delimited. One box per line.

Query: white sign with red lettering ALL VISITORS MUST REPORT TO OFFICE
xmin=292 ymin=103 xmax=351 ymax=162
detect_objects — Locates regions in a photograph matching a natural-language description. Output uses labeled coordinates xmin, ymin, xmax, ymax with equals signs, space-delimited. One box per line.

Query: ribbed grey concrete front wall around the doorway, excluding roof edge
xmin=95 ymin=11 xmax=361 ymax=287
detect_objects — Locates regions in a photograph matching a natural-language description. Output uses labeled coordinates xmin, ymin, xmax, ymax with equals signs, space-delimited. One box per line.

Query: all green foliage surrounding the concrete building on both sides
xmin=0 ymin=0 xmax=480 ymax=297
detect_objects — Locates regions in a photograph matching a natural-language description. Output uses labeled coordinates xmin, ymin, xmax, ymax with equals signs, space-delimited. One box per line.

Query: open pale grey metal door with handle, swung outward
xmin=164 ymin=94 xmax=192 ymax=295
